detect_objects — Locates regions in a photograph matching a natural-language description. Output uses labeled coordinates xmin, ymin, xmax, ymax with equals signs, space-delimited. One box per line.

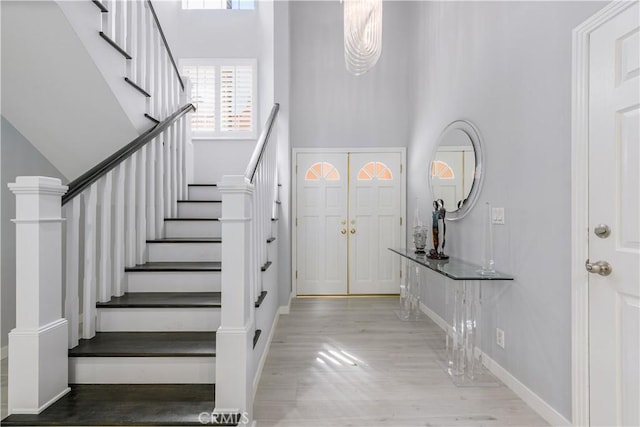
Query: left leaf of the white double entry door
xmin=296 ymin=153 xmax=348 ymax=295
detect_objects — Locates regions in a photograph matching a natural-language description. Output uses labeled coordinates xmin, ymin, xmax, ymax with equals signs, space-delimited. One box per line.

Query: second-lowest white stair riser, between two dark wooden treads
xmin=97 ymin=307 xmax=220 ymax=332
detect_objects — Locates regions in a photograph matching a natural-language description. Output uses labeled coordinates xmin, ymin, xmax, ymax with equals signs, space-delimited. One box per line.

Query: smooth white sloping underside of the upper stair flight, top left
xmin=0 ymin=1 xmax=139 ymax=180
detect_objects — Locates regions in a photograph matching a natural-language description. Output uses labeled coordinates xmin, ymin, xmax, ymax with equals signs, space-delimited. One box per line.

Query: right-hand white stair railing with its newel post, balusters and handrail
xmin=215 ymin=104 xmax=279 ymax=419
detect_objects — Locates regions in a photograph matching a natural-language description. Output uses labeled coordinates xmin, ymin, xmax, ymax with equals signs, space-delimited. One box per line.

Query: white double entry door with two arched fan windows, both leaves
xmin=294 ymin=150 xmax=405 ymax=295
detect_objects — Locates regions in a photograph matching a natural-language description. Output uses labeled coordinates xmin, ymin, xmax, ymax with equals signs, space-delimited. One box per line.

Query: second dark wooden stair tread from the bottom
xmin=69 ymin=332 xmax=216 ymax=357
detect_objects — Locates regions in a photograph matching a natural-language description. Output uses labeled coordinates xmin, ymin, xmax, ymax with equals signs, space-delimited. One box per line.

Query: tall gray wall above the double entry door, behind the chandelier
xmin=290 ymin=1 xmax=414 ymax=147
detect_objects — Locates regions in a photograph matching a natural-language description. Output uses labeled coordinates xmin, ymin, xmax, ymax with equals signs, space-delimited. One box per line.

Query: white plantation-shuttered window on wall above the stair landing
xmin=180 ymin=59 xmax=257 ymax=139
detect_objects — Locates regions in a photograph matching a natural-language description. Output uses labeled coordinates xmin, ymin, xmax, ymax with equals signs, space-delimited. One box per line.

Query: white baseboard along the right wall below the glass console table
xmin=420 ymin=302 xmax=572 ymax=426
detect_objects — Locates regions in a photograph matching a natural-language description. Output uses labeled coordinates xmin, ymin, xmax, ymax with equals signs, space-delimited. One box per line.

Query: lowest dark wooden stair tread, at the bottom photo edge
xmin=2 ymin=384 xmax=239 ymax=426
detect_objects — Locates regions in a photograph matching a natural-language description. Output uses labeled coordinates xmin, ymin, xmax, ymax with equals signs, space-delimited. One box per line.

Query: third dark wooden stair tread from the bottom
xmin=96 ymin=292 xmax=221 ymax=308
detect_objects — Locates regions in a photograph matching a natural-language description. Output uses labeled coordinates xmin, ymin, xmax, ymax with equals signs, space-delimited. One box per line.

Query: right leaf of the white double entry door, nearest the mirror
xmin=349 ymin=153 xmax=404 ymax=294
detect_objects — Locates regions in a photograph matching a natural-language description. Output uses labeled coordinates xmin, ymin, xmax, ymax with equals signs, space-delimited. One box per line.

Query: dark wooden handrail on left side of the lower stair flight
xmin=62 ymin=104 xmax=196 ymax=206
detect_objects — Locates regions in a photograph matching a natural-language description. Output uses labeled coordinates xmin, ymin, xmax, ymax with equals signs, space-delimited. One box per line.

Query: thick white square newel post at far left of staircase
xmin=8 ymin=176 xmax=69 ymax=414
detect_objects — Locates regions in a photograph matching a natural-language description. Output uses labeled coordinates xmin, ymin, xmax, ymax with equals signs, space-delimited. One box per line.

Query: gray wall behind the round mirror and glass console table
xmin=407 ymin=2 xmax=604 ymax=419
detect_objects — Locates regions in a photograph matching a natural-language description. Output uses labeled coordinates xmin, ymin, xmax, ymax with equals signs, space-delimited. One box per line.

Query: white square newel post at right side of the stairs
xmin=215 ymin=175 xmax=254 ymax=417
